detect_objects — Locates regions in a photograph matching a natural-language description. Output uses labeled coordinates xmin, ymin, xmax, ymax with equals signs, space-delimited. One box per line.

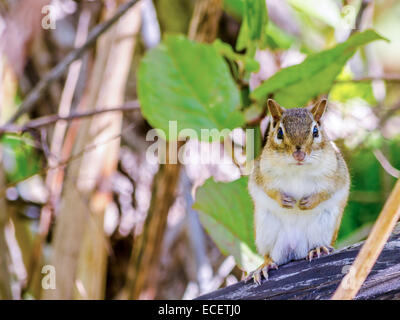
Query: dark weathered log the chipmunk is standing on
xmin=197 ymin=224 xmax=400 ymax=300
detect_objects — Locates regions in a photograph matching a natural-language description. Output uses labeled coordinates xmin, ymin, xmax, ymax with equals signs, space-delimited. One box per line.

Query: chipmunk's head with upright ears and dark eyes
xmin=265 ymin=99 xmax=328 ymax=166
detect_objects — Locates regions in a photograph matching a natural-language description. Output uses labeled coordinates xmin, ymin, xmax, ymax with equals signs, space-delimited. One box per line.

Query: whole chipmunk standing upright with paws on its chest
xmin=246 ymin=99 xmax=350 ymax=284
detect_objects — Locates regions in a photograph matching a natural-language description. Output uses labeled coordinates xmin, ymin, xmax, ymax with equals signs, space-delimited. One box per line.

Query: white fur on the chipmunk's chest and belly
xmin=249 ymin=175 xmax=347 ymax=264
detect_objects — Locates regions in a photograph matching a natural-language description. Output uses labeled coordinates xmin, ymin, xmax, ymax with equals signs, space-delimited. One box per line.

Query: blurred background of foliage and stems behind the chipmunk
xmin=0 ymin=0 xmax=400 ymax=299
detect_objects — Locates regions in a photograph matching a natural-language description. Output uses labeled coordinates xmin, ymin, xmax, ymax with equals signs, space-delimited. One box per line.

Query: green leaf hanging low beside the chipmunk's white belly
xmin=193 ymin=177 xmax=262 ymax=271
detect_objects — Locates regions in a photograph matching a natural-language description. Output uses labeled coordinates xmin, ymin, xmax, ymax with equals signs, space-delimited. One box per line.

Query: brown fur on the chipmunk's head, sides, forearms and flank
xmin=253 ymin=100 xmax=350 ymax=245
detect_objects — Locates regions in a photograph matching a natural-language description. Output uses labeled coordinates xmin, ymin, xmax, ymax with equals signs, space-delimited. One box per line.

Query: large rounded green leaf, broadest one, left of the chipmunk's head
xmin=138 ymin=36 xmax=244 ymax=139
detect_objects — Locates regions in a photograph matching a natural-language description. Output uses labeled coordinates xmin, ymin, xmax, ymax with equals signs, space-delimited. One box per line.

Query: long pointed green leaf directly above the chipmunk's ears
xmin=251 ymin=30 xmax=385 ymax=107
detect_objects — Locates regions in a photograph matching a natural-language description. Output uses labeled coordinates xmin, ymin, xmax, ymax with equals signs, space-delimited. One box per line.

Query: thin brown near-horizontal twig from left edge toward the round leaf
xmin=0 ymin=100 xmax=140 ymax=136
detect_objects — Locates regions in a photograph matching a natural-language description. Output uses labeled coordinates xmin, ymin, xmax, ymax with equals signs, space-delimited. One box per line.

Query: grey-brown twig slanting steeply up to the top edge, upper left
xmin=7 ymin=0 xmax=139 ymax=124
